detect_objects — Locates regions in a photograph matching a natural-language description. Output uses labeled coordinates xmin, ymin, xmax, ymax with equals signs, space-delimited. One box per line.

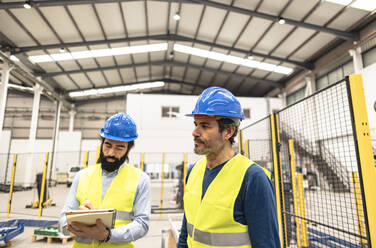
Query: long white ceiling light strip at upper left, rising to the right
xmin=29 ymin=43 xmax=168 ymax=63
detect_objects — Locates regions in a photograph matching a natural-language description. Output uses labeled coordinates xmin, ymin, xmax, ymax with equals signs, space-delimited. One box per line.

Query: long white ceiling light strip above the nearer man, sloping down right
xmin=173 ymin=44 xmax=293 ymax=75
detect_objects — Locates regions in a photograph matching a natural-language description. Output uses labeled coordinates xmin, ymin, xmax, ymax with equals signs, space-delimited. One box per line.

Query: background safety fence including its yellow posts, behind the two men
xmin=0 ymin=149 xmax=200 ymax=216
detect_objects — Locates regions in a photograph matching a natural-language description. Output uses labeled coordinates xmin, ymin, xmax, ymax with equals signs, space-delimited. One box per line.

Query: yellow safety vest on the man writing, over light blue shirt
xmin=73 ymin=164 xmax=141 ymax=248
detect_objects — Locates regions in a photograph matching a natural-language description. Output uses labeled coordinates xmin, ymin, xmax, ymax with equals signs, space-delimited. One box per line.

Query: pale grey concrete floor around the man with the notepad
xmin=0 ymin=181 xmax=182 ymax=248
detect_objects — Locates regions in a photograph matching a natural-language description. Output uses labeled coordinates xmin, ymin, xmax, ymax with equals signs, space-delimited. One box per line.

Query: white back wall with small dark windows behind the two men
xmin=127 ymin=94 xmax=282 ymax=156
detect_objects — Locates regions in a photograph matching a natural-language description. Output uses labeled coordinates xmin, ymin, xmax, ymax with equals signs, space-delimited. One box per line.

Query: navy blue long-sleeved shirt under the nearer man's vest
xmin=177 ymin=158 xmax=281 ymax=248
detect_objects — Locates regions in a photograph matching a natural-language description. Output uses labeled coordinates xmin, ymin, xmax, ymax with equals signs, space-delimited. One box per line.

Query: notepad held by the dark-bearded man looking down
xmin=65 ymin=209 xmax=116 ymax=228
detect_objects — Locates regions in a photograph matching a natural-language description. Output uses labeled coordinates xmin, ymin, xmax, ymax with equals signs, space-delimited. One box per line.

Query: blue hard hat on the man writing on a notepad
xmin=100 ymin=113 xmax=138 ymax=142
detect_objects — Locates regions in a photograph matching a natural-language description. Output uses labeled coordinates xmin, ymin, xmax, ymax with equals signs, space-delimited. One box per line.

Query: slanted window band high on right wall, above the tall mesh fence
xmin=316 ymin=60 xmax=354 ymax=90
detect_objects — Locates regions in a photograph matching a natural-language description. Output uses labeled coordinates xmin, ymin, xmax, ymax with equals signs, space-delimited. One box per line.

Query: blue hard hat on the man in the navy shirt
xmin=188 ymin=87 xmax=244 ymax=119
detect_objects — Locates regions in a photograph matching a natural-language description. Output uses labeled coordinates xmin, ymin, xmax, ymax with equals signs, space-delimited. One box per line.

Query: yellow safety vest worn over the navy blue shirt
xmin=184 ymin=154 xmax=270 ymax=248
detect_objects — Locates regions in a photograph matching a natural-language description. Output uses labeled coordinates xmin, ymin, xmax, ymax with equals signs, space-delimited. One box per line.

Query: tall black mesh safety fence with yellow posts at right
xmin=239 ymin=75 xmax=376 ymax=247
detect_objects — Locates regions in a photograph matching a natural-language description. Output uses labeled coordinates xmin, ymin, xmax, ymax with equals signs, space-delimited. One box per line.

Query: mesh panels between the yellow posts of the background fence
xmin=0 ymin=150 xmax=200 ymax=214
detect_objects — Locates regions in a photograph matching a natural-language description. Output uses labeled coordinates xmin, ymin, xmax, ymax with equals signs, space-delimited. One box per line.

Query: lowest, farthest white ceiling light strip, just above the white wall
xmin=69 ymin=81 xmax=165 ymax=98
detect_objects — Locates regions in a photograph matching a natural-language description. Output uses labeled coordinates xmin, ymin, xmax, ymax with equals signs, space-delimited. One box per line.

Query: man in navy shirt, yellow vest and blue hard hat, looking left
xmin=178 ymin=87 xmax=281 ymax=248
